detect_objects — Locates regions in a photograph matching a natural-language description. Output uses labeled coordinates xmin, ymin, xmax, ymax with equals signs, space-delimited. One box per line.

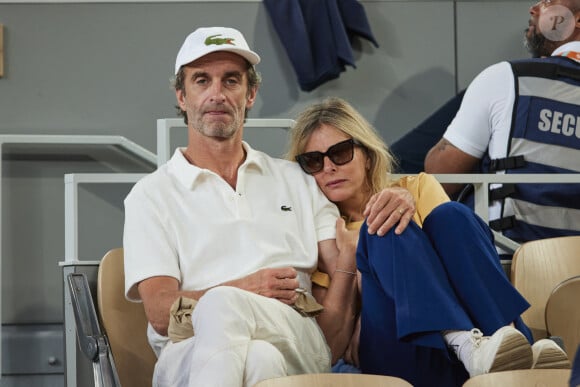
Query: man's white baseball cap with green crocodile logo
xmin=175 ymin=27 xmax=260 ymax=74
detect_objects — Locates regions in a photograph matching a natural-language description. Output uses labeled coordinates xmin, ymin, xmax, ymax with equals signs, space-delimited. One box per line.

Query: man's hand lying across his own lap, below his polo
xmin=231 ymin=267 xmax=299 ymax=305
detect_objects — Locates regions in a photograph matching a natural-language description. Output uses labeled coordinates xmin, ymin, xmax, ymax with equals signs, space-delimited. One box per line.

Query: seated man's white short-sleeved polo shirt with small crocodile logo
xmin=123 ymin=143 xmax=339 ymax=349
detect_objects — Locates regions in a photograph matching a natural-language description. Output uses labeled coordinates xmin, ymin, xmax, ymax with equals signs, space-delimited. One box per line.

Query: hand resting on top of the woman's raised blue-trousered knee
xmin=363 ymin=187 xmax=416 ymax=236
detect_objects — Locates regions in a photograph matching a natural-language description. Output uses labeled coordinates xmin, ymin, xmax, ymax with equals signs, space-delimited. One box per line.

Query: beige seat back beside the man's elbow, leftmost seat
xmin=97 ymin=248 xmax=157 ymax=387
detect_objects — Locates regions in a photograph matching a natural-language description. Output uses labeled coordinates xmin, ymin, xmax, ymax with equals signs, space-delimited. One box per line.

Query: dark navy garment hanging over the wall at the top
xmin=264 ymin=0 xmax=377 ymax=91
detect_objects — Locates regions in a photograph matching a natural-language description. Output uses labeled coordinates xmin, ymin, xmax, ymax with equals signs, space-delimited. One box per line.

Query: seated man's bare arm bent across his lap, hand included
xmin=138 ymin=267 xmax=299 ymax=336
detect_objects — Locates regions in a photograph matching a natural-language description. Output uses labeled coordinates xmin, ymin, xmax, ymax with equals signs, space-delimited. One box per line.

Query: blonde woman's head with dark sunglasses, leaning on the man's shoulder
xmin=286 ymin=98 xmax=394 ymax=215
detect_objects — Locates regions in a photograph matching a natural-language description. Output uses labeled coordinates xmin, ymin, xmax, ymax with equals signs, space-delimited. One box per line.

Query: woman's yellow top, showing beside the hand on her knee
xmin=311 ymin=172 xmax=449 ymax=288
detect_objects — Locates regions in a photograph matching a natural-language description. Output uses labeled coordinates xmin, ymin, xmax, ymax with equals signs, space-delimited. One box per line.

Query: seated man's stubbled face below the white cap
xmin=176 ymin=51 xmax=256 ymax=139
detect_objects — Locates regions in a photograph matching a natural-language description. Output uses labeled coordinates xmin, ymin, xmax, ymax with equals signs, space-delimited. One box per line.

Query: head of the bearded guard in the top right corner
xmin=524 ymin=0 xmax=580 ymax=58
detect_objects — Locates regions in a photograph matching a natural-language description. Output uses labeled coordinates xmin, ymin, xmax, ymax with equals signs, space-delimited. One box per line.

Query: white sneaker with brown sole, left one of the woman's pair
xmin=465 ymin=326 xmax=532 ymax=376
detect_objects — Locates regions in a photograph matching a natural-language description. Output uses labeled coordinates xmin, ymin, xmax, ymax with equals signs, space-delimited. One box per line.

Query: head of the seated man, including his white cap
xmin=173 ymin=27 xmax=261 ymax=135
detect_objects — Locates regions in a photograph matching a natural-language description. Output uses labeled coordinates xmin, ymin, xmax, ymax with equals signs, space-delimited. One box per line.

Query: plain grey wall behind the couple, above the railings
xmin=0 ymin=1 xmax=529 ymax=151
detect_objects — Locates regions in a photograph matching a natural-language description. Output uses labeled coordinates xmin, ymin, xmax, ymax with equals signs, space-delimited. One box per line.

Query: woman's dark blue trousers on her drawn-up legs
xmin=357 ymin=202 xmax=531 ymax=387
